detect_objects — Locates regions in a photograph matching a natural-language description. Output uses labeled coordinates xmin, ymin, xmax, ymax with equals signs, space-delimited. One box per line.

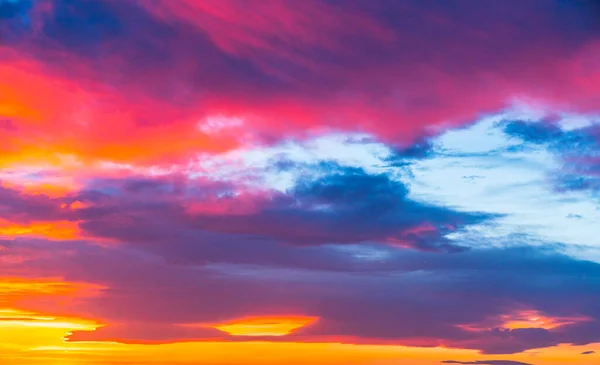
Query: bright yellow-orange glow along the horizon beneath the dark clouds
xmin=0 ymin=278 xmax=599 ymax=365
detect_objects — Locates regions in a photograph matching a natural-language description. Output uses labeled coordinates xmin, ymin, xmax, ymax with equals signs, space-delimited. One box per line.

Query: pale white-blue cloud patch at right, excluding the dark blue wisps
xmin=406 ymin=112 xmax=600 ymax=261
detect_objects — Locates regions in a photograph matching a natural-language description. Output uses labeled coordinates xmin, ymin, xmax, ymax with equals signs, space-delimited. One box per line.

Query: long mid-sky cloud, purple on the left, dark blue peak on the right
xmin=70 ymin=164 xmax=491 ymax=252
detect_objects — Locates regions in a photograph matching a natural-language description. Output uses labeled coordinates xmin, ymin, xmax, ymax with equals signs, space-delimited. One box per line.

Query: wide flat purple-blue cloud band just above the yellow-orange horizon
xmin=2 ymin=229 xmax=600 ymax=354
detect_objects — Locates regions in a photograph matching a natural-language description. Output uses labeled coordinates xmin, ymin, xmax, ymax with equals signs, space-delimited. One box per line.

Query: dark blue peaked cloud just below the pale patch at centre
xmin=190 ymin=164 xmax=488 ymax=251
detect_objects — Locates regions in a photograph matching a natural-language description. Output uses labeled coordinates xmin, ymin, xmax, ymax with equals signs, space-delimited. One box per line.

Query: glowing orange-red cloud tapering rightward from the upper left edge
xmin=0 ymin=53 xmax=236 ymax=166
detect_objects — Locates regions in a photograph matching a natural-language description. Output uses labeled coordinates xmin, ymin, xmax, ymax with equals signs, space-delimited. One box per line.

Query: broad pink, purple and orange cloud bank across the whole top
xmin=0 ymin=0 xmax=598 ymax=164
